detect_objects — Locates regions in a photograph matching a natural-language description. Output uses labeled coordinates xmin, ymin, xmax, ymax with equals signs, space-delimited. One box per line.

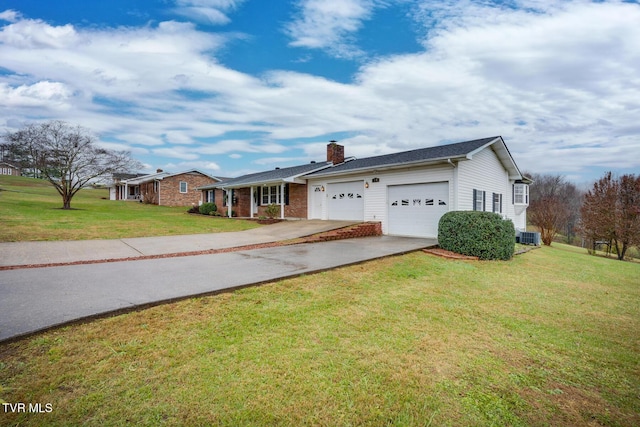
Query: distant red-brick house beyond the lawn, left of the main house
xmin=109 ymin=169 xmax=220 ymax=206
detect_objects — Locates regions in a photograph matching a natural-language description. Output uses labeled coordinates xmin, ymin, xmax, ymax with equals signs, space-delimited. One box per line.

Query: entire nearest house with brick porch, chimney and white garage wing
xmin=199 ymin=136 xmax=531 ymax=237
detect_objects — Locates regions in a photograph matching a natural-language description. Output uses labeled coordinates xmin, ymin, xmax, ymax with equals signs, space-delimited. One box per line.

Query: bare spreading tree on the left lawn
xmin=4 ymin=120 xmax=140 ymax=209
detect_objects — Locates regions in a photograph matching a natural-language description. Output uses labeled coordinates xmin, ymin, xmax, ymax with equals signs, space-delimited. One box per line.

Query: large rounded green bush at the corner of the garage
xmin=438 ymin=211 xmax=516 ymax=260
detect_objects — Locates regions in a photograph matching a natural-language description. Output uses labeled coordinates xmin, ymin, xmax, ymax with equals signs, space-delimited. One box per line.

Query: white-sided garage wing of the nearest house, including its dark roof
xmin=304 ymin=136 xmax=531 ymax=237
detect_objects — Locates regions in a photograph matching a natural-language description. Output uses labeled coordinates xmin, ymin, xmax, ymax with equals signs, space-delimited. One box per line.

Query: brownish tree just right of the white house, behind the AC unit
xmin=527 ymin=174 xmax=581 ymax=246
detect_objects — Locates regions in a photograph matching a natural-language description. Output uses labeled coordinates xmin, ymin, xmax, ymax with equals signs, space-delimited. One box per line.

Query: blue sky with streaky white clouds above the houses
xmin=0 ymin=0 xmax=640 ymax=183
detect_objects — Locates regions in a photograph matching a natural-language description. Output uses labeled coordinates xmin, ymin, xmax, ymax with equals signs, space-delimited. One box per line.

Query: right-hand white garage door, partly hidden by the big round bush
xmin=388 ymin=182 xmax=449 ymax=237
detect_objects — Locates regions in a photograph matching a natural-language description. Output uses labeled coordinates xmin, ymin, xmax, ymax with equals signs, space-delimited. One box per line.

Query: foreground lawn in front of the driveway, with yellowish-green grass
xmin=0 ymin=245 xmax=640 ymax=426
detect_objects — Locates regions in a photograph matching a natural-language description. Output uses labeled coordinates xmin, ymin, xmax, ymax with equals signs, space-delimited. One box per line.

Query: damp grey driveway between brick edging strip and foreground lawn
xmin=0 ymin=222 xmax=437 ymax=341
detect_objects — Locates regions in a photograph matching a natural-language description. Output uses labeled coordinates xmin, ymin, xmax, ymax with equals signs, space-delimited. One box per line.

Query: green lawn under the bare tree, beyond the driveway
xmin=0 ymin=175 xmax=258 ymax=242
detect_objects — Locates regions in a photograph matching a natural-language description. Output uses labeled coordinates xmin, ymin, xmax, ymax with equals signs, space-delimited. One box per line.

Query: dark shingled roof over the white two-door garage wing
xmin=305 ymin=136 xmax=500 ymax=178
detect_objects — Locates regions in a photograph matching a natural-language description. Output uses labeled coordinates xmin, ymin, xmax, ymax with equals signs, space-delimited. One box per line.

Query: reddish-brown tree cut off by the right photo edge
xmin=580 ymin=172 xmax=640 ymax=260
